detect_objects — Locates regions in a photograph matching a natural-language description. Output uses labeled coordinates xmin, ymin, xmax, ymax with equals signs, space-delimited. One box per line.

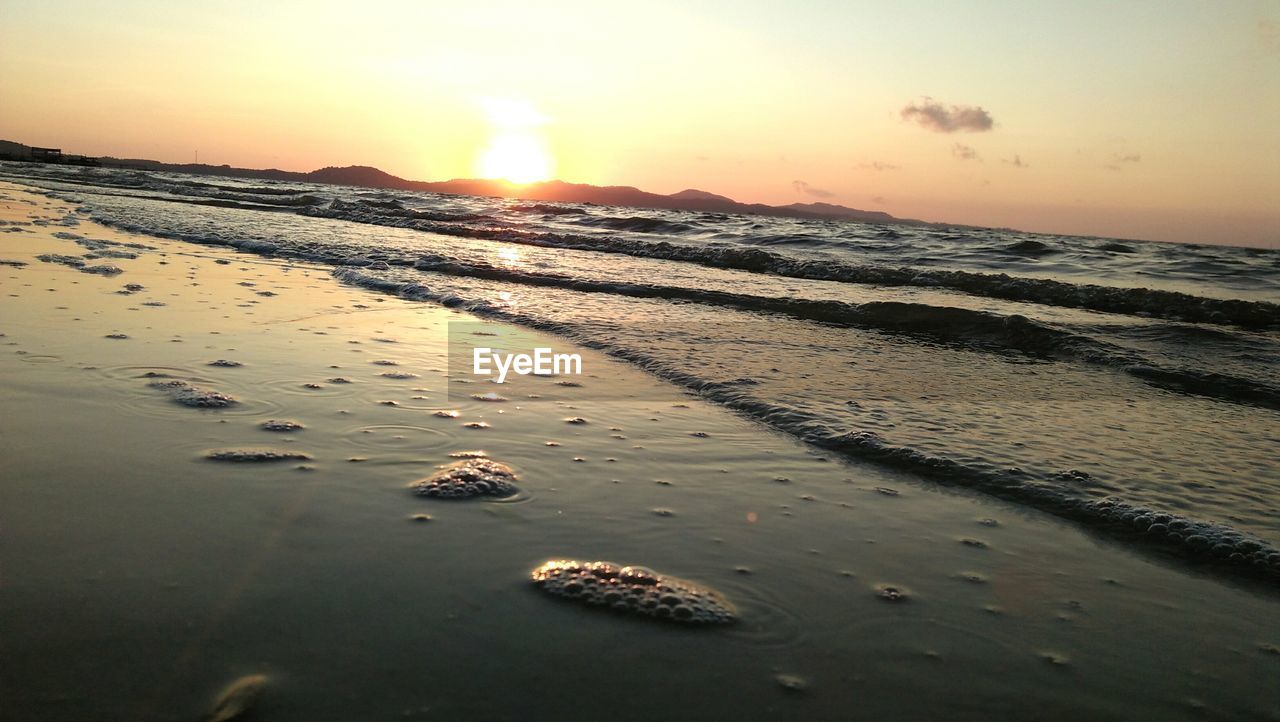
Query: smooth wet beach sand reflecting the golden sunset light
xmin=0 ymin=184 xmax=1280 ymax=721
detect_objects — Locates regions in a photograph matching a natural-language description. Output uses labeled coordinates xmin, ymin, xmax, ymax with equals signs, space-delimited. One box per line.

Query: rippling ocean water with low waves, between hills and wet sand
xmin=0 ymin=164 xmax=1280 ymax=580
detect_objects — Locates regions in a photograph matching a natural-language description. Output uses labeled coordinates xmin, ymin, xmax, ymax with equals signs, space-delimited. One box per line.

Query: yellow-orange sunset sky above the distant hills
xmin=0 ymin=0 xmax=1280 ymax=247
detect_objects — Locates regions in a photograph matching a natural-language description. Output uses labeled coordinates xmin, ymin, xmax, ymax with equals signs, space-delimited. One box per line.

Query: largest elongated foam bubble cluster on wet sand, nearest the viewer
xmin=531 ymin=559 xmax=737 ymax=625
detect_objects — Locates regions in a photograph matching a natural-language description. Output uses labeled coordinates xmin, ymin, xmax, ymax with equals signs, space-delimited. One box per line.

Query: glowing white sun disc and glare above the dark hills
xmin=476 ymin=99 xmax=554 ymax=183
